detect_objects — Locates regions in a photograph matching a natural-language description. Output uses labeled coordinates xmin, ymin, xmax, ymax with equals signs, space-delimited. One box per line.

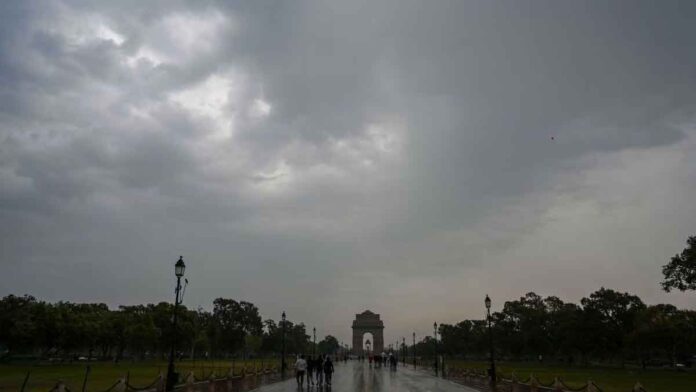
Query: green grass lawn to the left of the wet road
xmin=0 ymin=359 xmax=279 ymax=392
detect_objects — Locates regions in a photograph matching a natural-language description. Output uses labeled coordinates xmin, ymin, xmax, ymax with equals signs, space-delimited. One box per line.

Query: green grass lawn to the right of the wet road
xmin=448 ymin=361 xmax=696 ymax=392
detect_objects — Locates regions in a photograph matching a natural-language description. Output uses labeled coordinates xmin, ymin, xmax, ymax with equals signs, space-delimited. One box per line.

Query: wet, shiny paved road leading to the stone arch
xmin=257 ymin=361 xmax=477 ymax=392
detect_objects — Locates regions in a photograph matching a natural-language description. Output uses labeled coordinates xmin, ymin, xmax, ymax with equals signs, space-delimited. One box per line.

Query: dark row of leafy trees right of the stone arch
xmin=436 ymin=288 xmax=696 ymax=366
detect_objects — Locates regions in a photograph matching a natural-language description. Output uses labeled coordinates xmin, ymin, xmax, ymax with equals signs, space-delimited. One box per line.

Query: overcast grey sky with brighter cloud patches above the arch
xmin=0 ymin=0 xmax=696 ymax=343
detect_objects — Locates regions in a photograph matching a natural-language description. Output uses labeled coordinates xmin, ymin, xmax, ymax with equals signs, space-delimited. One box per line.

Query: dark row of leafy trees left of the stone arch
xmin=0 ymin=295 xmax=338 ymax=360
